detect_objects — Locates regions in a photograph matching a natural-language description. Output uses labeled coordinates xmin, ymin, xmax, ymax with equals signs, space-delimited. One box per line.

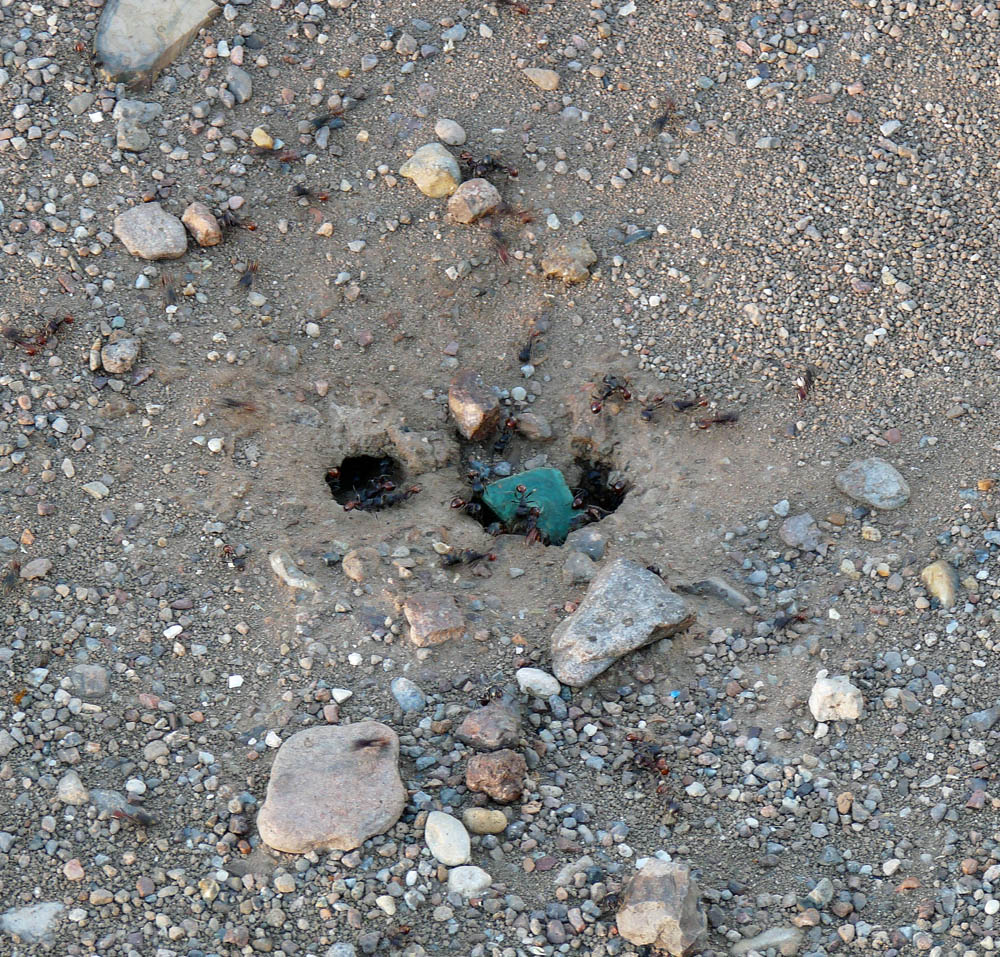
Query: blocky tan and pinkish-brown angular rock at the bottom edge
xmin=617 ymin=858 xmax=708 ymax=957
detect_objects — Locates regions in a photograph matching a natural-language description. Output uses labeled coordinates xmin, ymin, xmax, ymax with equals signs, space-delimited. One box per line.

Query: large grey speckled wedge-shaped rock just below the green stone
xmin=552 ymin=558 xmax=694 ymax=688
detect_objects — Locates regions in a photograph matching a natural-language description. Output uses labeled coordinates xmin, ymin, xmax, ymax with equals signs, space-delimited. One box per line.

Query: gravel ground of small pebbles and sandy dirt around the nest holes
xmin=0 ymin=0 xmax=1000 ymax=957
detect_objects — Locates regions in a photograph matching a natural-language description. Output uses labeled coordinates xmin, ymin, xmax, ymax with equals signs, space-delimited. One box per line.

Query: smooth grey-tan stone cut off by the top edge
xmin=94 ymin=0 xmax=221 ymax=87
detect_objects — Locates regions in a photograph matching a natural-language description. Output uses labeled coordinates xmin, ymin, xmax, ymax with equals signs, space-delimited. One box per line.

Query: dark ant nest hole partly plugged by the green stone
xmin=451 ymin=458 xmax=631 ymax=545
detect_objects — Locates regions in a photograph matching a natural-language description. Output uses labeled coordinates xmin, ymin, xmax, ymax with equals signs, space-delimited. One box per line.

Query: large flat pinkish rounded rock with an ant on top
xmin=257 ymin=721 xmax=406 ymax=854
